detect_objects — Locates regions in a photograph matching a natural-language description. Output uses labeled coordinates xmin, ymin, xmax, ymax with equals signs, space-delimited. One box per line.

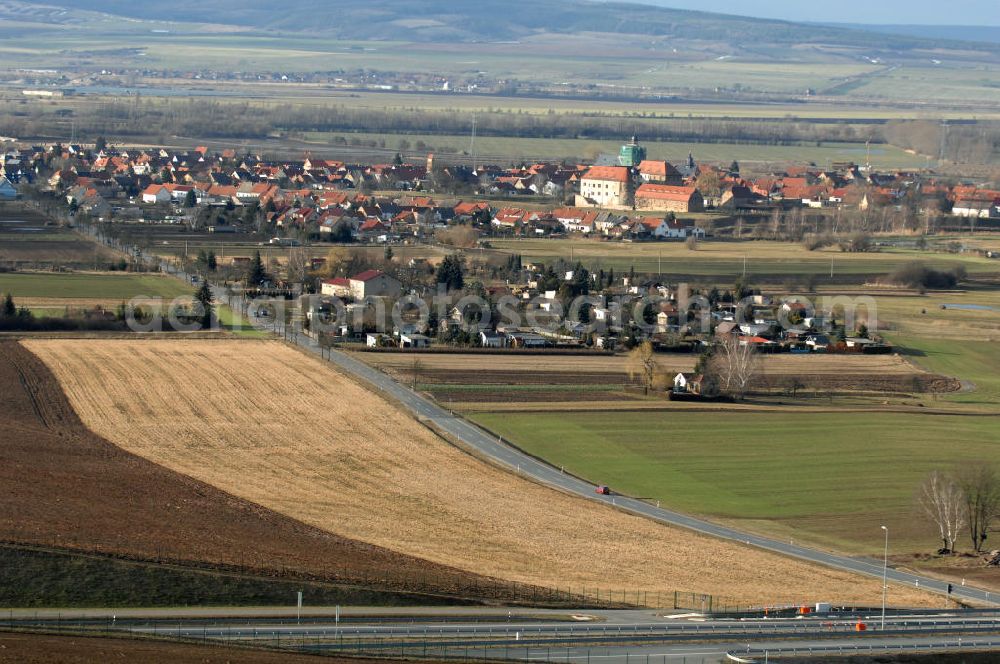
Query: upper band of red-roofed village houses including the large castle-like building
xmin=0 ymin=137 xmax=1000 ymax=243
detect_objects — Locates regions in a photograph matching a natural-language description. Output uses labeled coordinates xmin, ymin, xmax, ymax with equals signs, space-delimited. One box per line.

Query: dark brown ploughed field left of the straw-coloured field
xmin=0 ymin=341 xmax=508 ymax=594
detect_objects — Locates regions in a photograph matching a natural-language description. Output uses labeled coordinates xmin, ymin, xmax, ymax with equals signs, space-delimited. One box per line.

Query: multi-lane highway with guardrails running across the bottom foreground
xmin=13 ymin=607 xmax=1000 ymax=664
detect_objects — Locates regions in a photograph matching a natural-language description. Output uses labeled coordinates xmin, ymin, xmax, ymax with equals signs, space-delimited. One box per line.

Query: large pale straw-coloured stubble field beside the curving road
xmin=26 ymin=340 xmax=929 ymax=604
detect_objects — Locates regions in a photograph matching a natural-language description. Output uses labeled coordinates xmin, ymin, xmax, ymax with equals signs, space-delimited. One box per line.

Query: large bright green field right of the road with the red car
xmin=474 ymin=412 xmax=1000 ymax=553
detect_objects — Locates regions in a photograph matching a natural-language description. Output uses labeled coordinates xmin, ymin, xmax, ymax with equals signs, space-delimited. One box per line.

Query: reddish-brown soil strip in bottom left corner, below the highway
xmin=0 ymin=634 xmax=376 ymax=664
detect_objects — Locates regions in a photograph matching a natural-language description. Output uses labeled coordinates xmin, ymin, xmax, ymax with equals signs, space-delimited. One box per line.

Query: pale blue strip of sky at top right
xmin=628 ymin=0 xmax=1000 ymax=26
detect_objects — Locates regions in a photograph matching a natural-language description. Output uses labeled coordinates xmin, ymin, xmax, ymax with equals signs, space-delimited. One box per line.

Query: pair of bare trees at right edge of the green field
xmin=917 ymin=463 xmax=1000 ymax=554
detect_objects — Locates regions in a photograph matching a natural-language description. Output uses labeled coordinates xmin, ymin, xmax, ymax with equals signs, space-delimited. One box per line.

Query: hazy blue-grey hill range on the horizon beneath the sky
xmin=33 ymin=0 xmax=1000 ymax=49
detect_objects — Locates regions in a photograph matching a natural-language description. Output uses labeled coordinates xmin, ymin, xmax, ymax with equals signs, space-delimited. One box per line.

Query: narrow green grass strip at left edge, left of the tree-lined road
xmin=0 ymin=272 xmax=193 ymax=300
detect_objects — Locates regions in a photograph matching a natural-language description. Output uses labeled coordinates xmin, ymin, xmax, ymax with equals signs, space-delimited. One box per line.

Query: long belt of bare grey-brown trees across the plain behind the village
xmin=3 ymin=98 xmax=881 ymax=145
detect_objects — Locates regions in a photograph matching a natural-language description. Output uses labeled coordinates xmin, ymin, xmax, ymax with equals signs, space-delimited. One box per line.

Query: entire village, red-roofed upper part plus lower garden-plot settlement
xmin=0 ymin=137 xmax=1000 ymax=394
